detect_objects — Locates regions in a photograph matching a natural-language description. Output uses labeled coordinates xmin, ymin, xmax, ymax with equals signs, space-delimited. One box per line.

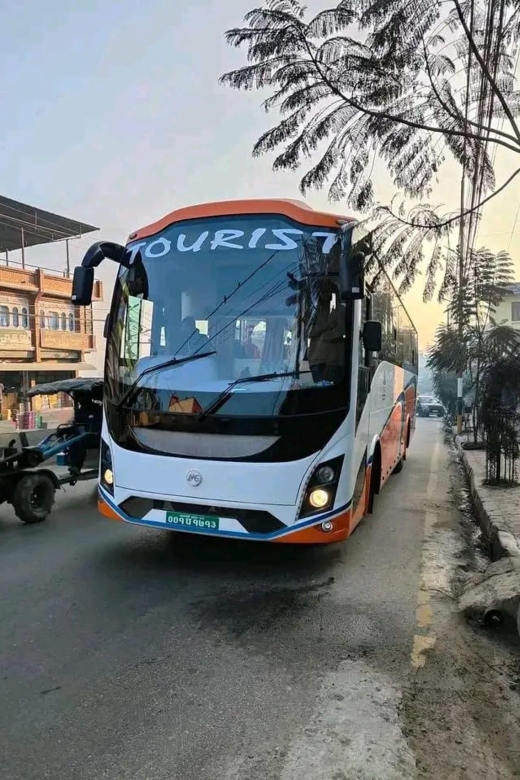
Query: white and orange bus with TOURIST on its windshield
xmin=72 ymin=200 xmax=418 ymax=543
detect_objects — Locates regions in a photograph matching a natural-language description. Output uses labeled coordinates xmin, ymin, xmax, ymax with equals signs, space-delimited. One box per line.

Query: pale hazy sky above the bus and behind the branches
xmin=0 ymin=0 xmax=520 ymax=368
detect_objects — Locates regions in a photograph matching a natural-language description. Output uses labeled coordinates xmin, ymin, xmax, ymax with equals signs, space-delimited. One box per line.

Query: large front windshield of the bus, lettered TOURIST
xmin=106 ymin=214 xmax=349 ymax=417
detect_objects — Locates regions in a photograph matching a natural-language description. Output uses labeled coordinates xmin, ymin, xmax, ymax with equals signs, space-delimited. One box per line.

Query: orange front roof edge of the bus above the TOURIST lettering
xmin=129 ymin=198 xmax=356 ymax=241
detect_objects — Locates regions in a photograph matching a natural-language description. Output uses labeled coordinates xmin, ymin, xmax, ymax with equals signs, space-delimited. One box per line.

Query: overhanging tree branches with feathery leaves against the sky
xmin=221 ymin=0 xmax=520 ymax=298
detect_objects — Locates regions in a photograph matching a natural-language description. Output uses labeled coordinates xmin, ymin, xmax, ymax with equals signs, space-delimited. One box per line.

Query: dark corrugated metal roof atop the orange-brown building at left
xmin=0 ymin=195 xmax=99 ymax=252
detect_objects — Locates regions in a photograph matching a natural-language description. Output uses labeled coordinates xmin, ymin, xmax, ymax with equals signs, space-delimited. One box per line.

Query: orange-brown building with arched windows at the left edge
xmin=0 ymin=196 xmax=103 ymax=419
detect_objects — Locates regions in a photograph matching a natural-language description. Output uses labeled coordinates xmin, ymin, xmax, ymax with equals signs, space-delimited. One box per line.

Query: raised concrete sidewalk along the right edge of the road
xmin=455 ymin=438 xmax=520 ymax=633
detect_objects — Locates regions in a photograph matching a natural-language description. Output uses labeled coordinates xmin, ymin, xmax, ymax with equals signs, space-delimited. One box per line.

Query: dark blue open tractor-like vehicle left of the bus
xmin=0 ymin=377 xmax=103 ymax=523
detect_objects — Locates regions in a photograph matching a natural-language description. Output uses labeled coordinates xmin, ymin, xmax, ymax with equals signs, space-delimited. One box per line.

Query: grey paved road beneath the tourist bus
xmin=0 ymin=420 xmax=513 ymax=780
